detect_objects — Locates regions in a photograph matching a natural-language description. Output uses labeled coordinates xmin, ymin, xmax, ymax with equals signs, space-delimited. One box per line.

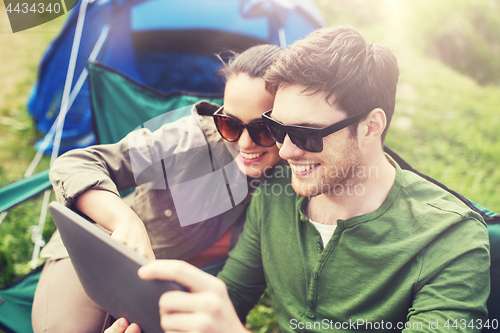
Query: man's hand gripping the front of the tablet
xmin=139 ymin=260 xmax=248 ymax=333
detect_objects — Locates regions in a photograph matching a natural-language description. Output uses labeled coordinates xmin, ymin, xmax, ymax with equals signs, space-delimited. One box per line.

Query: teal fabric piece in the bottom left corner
xmin=0 ymin=266 xmax=43 ymax=333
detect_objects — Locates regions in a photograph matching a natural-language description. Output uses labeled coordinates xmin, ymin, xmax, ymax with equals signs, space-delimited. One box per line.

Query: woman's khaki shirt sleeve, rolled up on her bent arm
xmin=49 ymin=115 xmax=207 ymax=206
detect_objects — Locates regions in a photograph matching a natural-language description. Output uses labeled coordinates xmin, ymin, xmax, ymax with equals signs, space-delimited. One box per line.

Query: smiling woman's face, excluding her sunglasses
xmin=224 ymin=73 xmax=281 ymax=179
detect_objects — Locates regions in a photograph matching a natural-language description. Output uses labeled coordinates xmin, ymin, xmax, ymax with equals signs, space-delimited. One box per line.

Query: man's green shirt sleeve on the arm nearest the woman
xmin=218 ymin=189 xmax=266 ymax=323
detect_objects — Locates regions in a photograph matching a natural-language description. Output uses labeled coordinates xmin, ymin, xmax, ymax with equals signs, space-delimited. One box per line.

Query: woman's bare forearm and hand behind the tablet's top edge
xmin=75 ymin=190 xmax=155 ymax=260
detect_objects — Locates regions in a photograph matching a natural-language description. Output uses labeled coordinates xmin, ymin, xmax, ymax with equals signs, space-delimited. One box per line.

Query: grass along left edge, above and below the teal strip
xmin=0 ymin=1 xmax=63 ymax=287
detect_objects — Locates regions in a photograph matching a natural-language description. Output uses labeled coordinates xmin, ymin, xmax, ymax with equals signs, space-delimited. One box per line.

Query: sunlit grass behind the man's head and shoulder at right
xmin=317 ymin=0 xmax=500 ymax=212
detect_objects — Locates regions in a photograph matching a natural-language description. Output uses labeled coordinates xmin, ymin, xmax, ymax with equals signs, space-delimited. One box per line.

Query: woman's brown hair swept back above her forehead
xmin=218 ymin=44 xmax=283 ymax=80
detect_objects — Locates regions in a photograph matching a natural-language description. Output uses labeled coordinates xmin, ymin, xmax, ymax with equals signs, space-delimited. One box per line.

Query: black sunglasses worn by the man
xmin=262 ymin=109 xmax=373 ymax=153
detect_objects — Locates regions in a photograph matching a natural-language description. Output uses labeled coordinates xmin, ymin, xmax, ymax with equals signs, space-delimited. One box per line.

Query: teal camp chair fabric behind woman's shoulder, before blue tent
xmin=87 ymin=62 xmax=222 ymax=144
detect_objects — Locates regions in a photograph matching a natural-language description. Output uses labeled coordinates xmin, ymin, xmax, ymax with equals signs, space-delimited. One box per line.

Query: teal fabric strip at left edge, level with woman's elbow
xmin=0 ymin=170 xmax=51 ymax=213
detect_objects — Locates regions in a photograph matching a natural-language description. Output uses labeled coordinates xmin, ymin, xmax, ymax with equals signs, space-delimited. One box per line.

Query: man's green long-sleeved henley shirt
xmin=219 ymin=162 xmax=490 ymax=332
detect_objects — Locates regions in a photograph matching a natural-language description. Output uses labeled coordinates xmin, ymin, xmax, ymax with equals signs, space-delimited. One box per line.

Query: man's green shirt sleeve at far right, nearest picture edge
xmin=403 ymin=218 xmax=490 ymax=333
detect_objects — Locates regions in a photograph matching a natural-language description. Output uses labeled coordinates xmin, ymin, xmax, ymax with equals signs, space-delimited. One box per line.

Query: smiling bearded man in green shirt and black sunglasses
xmin=106 ymin=27 xmax=490 ymax=333
